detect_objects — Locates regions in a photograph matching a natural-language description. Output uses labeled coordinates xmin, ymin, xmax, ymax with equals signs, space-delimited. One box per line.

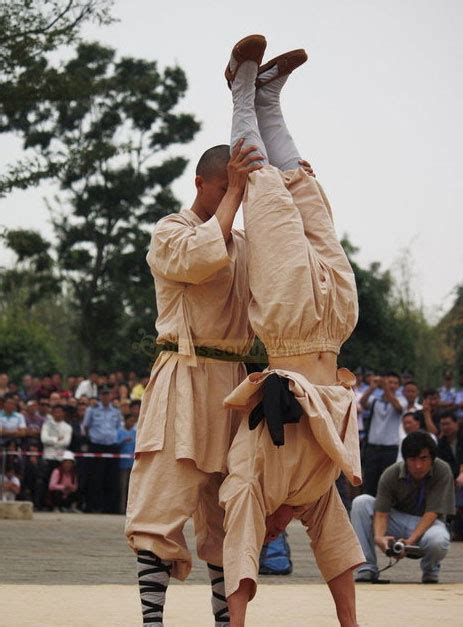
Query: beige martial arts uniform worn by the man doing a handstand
xmin=220 ymin=166 xmax=364 ymax=597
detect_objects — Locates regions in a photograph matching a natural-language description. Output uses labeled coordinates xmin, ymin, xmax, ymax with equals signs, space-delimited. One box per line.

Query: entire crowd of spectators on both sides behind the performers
xmin=0 ymin=368 xmax=463 ymax=539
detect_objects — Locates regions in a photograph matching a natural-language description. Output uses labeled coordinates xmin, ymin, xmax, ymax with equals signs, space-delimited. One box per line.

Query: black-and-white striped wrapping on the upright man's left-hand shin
xmin=137 ymin=551 xmax=172 ymax=627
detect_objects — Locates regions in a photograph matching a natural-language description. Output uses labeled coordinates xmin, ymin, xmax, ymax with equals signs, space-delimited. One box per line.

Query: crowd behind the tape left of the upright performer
xmin=0 ymin=372 xmax=148 ymax=513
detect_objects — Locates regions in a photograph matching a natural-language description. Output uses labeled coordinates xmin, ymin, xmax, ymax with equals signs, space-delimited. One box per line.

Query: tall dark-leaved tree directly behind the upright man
xmin=0 ymin=43 xmax=199 ymax=368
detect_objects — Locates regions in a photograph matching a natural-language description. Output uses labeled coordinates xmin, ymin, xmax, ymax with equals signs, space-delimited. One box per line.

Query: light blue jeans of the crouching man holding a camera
xmin=351 ymin=494 xmax=450 ymax=580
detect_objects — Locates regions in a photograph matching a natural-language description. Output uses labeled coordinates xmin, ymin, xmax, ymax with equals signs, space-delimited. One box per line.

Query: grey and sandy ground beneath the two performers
xmin=0 ymin=514 xmax=463 ymax=627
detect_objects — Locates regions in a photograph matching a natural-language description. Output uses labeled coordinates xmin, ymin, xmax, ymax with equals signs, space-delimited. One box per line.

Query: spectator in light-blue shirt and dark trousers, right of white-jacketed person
xmin=83 ymin=387 xmax=122 ymax=513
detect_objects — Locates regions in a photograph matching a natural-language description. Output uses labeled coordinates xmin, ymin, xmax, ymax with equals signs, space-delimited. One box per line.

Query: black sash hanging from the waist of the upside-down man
xmin=249 ymin=374 xmax=302 ymax=446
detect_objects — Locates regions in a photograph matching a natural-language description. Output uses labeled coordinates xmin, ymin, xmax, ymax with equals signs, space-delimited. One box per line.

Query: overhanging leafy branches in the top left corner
xmin=0 ymin=0 xmax=113 ymax=196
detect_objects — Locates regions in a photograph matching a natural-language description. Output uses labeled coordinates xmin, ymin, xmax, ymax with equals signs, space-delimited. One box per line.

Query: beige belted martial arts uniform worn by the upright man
xmin=126 ymin=210 xmax=253 ymax=579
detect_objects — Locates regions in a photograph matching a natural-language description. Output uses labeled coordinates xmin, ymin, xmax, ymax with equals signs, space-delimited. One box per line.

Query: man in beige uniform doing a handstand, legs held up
xmin=220 ymin=35 xmax=364 ymax=627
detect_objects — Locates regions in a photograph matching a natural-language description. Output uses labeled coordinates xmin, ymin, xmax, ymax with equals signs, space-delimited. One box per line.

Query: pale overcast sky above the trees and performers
xmin=0 ymin=0 xmax=463 ymax=320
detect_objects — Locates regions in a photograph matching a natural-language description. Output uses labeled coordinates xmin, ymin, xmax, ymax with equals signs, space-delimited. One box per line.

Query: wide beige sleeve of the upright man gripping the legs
xmin=146 ymin=216 xmax=229 ymax=283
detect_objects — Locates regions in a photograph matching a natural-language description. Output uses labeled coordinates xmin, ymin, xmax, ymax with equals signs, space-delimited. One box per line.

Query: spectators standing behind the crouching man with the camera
xmin=355 ymin=369 xmax=463 ymax=540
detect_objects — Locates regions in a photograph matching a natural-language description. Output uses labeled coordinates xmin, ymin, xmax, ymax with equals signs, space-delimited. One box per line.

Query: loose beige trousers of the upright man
xmin=125 ymin=417 xmax=224 ymax=580
